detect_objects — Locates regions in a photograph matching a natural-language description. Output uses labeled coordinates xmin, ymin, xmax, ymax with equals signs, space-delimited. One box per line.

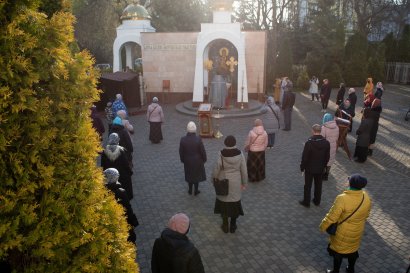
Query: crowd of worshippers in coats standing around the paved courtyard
xmin=88 ymin=77 xmax=384 ymax=273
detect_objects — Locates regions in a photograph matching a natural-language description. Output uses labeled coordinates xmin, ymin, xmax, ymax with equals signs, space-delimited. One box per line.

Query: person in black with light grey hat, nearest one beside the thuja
xmin=104 ymin=168 xmax=139 ymax=244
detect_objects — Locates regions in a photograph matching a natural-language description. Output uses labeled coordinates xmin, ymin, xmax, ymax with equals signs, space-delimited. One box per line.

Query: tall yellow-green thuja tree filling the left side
xmin=0 ymin=0 xmax=138 ymax=272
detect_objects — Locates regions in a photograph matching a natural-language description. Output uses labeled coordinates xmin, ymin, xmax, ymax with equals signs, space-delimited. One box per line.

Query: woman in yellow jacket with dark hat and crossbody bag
xmin=319 ymin=174 xmax=371 ymax=273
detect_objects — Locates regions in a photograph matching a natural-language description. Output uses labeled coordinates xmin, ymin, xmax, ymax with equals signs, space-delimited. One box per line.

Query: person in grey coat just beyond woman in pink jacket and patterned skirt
xmin=260 ymin=97 xmax=280 ymax=148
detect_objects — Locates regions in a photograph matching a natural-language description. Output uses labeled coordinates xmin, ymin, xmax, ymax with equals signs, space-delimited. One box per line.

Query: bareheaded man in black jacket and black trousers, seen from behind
xmin=299 ymin=124 xmax=330 ymax=208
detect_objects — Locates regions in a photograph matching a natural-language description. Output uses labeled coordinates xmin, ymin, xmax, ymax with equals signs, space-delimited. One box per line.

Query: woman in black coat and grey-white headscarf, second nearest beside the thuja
xmin=101 ymin=133 xmax=133 ymax=199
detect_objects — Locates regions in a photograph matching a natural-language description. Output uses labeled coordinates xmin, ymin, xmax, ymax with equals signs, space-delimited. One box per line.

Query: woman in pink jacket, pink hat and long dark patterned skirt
xmin=245 ymin=119 xmax=268 ymax=182
